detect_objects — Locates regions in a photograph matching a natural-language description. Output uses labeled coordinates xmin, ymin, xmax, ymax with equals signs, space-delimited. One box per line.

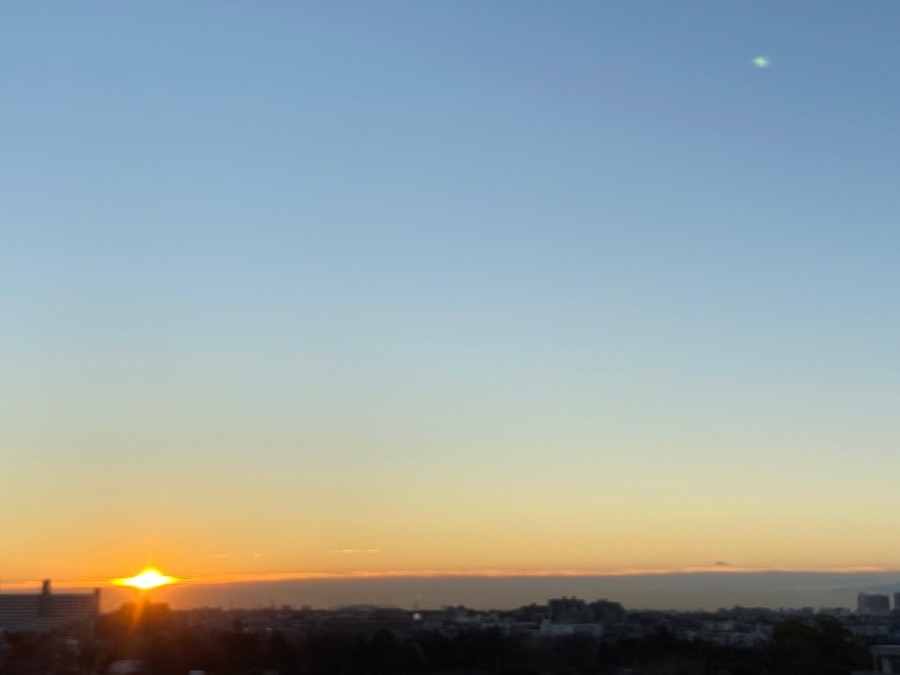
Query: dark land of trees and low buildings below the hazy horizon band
xmin=0 ymin=597 xmax=900 ymax=675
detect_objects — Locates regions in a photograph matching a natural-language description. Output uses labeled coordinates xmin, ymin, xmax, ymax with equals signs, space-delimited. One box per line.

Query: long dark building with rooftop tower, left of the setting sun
xmin=0 ymin=579 xmax=100 ymax=634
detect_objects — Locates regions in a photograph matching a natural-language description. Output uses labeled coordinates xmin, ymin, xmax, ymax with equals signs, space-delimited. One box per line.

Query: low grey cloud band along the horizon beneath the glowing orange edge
xmin=103 ymin=572 xmax=900 ymax=610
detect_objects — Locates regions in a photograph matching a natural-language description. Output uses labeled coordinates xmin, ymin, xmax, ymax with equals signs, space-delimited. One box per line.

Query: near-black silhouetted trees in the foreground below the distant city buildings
xmin=0 ymin=616 xmax=871 ymax=675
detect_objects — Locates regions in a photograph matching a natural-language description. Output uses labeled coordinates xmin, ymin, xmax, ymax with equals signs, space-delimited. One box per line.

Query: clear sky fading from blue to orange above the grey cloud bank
xmin=0 ymin=0 xmax=900 ymax=608
